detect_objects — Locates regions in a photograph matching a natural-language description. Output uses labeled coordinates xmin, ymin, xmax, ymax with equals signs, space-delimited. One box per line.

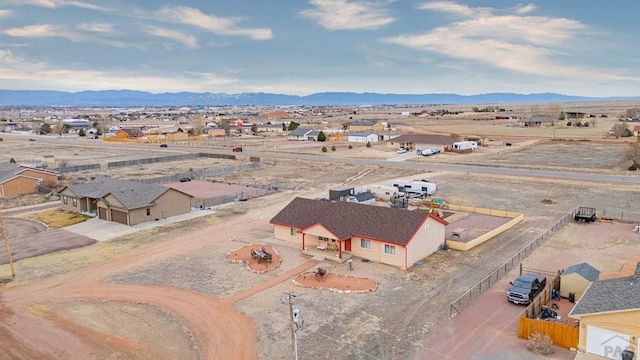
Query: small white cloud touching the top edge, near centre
xmin=299 ymin=0 xmax=395 ymax=30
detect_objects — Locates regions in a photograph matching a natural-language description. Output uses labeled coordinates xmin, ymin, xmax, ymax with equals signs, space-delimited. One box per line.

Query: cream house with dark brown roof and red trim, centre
xmin=270 ymin=197 xmax=448 ymax=269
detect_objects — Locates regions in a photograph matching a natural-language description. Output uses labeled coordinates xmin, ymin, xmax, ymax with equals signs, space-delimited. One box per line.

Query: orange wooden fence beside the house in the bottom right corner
xmin=518 ymin=316 xmax=580 ymax=349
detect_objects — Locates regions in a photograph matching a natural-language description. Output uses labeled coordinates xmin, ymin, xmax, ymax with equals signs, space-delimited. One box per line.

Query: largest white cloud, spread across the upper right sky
xmin=382 ymin=2 xmax=632 ymax=79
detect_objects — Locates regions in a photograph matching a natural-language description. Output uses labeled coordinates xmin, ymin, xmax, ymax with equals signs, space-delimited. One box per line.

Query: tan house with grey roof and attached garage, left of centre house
xmin=60 ymin=178 xmax=191 ymax=225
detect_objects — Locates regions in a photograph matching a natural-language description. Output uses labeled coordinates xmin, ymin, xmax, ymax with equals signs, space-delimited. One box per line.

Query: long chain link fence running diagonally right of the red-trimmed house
xmin=449 ymin=208 xmax=578 ymax=318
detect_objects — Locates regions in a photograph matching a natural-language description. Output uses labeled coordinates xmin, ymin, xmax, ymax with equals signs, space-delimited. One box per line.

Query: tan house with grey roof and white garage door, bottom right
xmin=569 ymin=263 xmax=640 ymax=359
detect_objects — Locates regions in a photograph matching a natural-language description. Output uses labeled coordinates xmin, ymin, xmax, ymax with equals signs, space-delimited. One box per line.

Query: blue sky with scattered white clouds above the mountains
xmin=0 ymin=0 xmax=640 ymax=96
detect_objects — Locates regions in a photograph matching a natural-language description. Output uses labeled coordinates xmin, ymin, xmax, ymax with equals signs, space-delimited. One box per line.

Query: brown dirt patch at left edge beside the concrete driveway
xmin=0 ymin=218 xmax=96 ymax=264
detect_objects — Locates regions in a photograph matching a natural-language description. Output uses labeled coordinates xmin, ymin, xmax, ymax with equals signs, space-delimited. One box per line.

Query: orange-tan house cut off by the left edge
xmin=0 ymin=164 xmax=60 ymax=197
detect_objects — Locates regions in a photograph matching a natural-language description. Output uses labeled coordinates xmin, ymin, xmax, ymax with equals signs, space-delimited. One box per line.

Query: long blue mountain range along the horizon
xmin=0 ymin=90 xmax=640 ymax=107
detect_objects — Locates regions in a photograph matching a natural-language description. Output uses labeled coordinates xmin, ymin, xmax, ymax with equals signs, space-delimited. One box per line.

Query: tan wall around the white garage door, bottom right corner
xmin=578 ymin=310 xmax=640 ymax=351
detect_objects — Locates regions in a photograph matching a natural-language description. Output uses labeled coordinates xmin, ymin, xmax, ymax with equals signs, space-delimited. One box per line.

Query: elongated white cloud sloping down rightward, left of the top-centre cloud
xmin=156 ymin=6 xmax=273 ymax=40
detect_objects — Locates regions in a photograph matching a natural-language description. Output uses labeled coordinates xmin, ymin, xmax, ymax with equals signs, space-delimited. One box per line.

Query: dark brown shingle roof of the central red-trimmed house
xmin=270 ymin=198 xmax=447 ymax=245
